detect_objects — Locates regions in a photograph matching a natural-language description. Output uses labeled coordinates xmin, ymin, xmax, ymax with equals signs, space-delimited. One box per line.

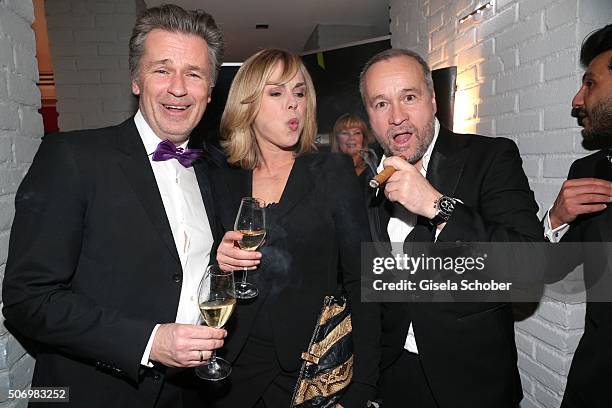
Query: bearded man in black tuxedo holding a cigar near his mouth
xmin=360 ymin=49 xmax=542 ymax=408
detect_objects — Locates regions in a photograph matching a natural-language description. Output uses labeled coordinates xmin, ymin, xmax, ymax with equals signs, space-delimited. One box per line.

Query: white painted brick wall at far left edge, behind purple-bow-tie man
xmin=0 ymin=0 xmax=43 ymax=408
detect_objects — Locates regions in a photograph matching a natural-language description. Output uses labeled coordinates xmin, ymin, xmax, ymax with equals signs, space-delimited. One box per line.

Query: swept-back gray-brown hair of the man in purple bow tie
xmin=129 ymin=4 xmax=224 ymax=86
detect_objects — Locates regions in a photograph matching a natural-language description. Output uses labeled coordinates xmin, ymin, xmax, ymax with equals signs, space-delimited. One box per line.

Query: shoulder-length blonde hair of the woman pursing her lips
xmin=220 ymin=49 xmax=317 ymax=170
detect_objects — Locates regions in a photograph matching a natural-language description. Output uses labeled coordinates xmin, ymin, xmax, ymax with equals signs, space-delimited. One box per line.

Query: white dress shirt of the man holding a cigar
xmin=378 ymin=118 xmax=440 ymax=354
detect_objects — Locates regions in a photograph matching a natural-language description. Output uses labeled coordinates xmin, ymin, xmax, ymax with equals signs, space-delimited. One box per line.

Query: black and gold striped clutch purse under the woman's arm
xmin=291 ymin=294 xmax=353 ymax=408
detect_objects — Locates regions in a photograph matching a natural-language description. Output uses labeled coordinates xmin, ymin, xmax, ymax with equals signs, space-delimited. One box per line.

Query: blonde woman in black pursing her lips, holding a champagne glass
xmin=213 ymin=49 xmax=380 ymax=408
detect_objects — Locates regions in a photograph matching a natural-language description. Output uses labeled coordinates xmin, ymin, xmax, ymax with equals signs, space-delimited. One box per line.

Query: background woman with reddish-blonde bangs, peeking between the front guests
xmin=329 ymin=113 xmax=372 ymax=176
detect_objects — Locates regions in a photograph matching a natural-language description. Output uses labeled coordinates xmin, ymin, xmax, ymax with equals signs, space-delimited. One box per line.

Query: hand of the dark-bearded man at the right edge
xmin=548 ymin=178 xmax=612 ymax=229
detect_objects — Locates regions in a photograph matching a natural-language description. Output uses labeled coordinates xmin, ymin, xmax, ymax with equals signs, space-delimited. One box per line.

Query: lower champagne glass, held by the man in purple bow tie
xmin=195 ymin=265 xmax=236 ymax=381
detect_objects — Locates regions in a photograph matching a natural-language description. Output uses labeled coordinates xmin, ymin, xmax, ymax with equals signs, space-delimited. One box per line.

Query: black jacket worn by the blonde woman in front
xmin=213 ymin=153 xmax=379 ymax=407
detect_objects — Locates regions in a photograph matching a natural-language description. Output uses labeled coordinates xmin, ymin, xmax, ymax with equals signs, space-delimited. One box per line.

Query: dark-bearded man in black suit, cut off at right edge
xmin=544 ymin=24 xmax=612 ymax=408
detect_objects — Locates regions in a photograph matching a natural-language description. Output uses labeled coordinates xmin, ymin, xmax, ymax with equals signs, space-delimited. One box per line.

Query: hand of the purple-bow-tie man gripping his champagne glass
xmin=149 ymin=323 xmax=227 ymax=368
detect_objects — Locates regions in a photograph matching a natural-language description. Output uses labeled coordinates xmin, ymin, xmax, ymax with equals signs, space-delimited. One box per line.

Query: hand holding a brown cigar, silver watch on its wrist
xmin=384 ymin=156 xmax=442 ymax=219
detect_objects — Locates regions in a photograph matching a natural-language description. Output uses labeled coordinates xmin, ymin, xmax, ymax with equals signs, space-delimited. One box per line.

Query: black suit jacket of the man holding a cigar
xmin=365 ymin=127 xmax=542 ymax=408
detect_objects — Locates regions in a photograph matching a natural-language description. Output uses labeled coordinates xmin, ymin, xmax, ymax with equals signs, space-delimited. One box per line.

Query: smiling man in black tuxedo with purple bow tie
xmin=3 ymin=5 xmax=226 ymax=407
